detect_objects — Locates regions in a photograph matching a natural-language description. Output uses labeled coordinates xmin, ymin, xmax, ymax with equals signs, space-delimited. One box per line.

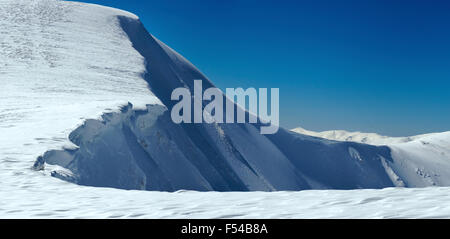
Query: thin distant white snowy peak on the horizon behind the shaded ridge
xmin=292 ymin=127 xmax=435 ymax=145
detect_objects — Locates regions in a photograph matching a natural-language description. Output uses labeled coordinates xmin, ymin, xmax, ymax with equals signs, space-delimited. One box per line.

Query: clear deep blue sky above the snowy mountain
xmin=78 ymin=0 xmax=450 ymax=136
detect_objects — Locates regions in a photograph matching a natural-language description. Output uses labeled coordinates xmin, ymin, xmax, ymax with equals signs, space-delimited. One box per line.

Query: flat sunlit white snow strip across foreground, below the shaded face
xmin=0 ymin=186 xmax=450 ymax=218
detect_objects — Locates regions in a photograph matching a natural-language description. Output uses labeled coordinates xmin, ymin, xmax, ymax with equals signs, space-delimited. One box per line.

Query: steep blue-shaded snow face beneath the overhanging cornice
xmin=35 ymin=11 xmax=401 ymax=191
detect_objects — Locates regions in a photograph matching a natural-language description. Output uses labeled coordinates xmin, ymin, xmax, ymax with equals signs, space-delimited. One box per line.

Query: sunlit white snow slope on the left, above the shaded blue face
xmin=0 ymin=0 xmax=159 ymax=181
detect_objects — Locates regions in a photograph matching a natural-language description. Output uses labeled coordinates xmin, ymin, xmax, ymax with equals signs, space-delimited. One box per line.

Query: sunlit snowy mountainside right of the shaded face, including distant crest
xmin=292 ymin=128 xmax=450 ymax=187
